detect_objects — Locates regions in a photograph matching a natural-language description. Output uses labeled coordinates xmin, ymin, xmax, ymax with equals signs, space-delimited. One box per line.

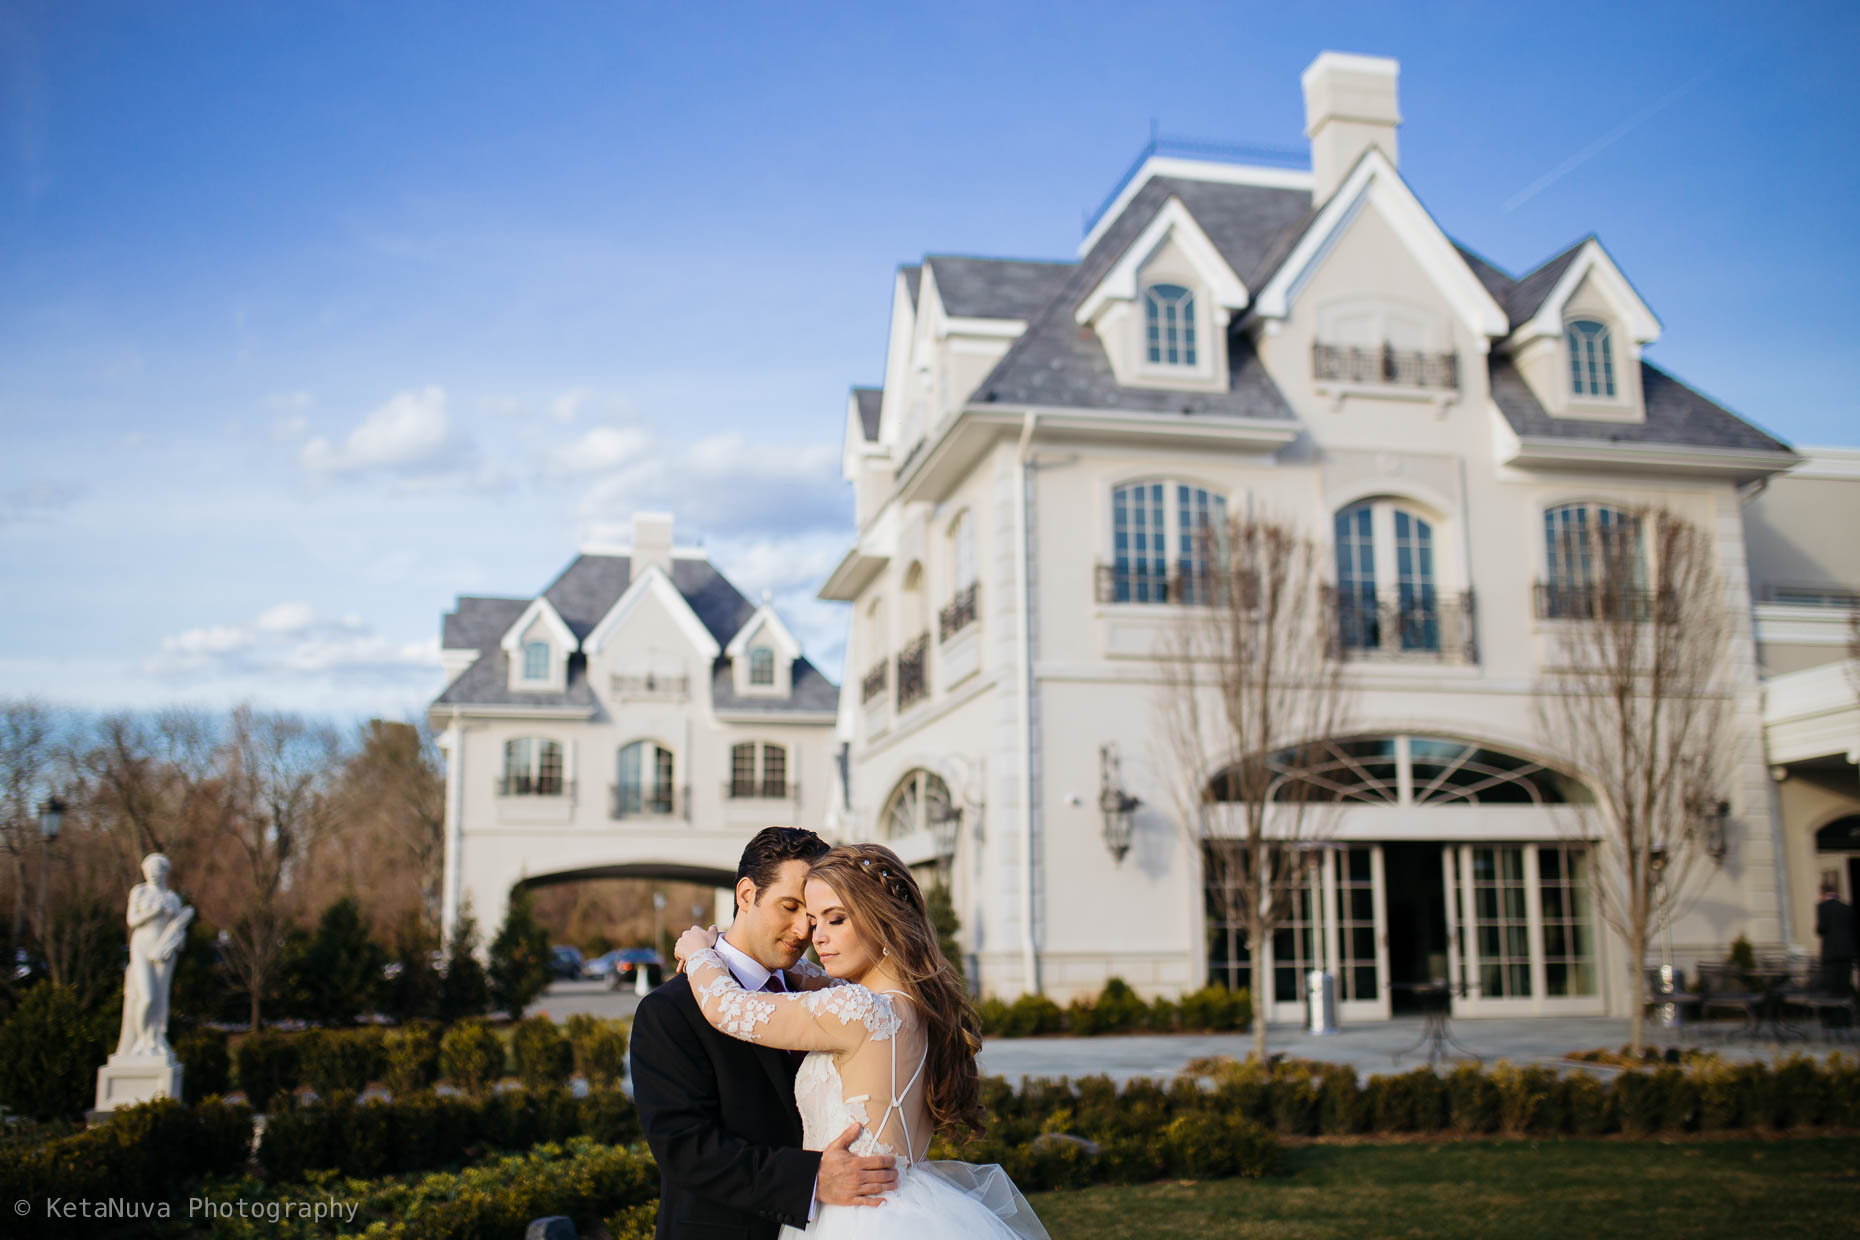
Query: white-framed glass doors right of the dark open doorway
xmin=1442 ymin=844 xmax=1601 ymax=1015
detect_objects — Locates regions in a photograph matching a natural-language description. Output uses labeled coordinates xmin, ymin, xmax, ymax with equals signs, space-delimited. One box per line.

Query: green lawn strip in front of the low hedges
xmin=1032 ymin=1138 xmax=1860 ymax=1240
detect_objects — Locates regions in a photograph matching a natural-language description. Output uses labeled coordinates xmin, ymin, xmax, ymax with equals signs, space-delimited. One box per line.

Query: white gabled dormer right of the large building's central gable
xmin=1505 ymin=236 xmax=1659 ymax=422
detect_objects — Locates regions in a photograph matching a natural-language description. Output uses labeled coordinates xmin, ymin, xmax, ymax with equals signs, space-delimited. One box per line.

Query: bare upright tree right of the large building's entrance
xmin=1536 ymin=508 xmax=1735 ymax=1052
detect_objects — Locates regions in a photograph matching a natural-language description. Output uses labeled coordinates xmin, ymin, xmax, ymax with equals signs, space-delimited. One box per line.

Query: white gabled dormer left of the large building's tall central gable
xmin=1073 ymin=197 xmax=1250 ymax=390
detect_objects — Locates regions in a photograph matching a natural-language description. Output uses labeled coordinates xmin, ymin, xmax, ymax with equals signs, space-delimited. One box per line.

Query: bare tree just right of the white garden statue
xmin=221 ymin=706 xmax=340 ymax=1030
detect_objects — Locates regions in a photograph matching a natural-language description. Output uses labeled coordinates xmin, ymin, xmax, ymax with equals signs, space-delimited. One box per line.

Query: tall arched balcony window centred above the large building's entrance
xmin=1335 ymin=500 xmax=1442 ymax=653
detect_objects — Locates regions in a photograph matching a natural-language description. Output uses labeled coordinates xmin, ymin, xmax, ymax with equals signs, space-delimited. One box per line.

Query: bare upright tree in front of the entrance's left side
xmin=1159 ymin=513 xmax=1349 ymax=1056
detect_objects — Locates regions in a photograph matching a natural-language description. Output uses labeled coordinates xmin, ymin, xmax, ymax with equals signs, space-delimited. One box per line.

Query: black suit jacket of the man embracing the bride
xmin=632 ymin=974 xmax=820 ymax=1240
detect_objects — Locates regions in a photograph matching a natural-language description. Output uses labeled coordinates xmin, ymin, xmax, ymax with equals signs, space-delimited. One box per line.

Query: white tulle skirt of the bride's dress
xmin=781 ymin=1160 xmax=1049 ymax=1240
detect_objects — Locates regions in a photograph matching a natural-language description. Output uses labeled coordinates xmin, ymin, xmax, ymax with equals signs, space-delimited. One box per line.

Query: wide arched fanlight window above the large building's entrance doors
xmin=1209 ymin=736 xmax=1592 ymax=805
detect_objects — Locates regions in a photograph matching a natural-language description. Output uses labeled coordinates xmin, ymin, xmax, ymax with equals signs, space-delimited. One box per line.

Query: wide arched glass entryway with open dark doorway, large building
xmin=1207 ymin=732 xmax=1603 ymax=1021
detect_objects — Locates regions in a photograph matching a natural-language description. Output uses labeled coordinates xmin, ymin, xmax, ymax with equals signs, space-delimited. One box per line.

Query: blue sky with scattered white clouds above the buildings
xmin=0 ymin=0 xmax=1860 ymax=716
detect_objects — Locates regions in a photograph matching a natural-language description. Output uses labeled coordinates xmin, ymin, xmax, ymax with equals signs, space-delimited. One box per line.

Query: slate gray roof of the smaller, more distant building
xmin=433 ymin=554 xmax=839 ymax=714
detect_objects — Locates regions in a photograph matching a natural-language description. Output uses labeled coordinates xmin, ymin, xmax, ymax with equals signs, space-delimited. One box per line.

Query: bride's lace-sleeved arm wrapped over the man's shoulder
xmin=684 ymin=948 xmax=900 ymax=1052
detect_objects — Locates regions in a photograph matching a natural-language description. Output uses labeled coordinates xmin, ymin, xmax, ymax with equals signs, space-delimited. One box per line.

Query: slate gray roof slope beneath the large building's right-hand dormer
xmin=1488 ymin=355 xmax=1791 ymax=454
